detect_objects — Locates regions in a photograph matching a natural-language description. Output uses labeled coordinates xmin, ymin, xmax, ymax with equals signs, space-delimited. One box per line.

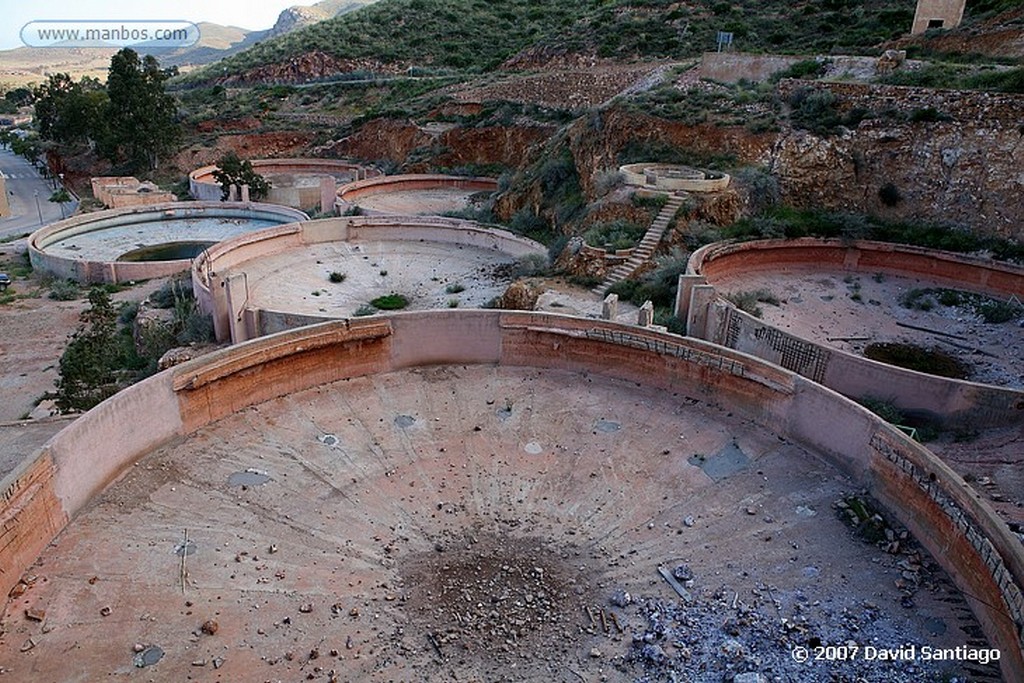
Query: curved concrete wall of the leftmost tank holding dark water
xmin=29 ymin=202 xmax=308 ymax=283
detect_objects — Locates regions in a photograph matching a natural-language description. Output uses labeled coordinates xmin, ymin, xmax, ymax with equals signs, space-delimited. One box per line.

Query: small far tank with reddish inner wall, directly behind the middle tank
xmin=335 ymin=174 xmax=498 ymax=216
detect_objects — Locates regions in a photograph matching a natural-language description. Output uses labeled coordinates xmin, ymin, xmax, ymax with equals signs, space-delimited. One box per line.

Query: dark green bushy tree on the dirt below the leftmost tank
xmin=56 ymin=287 xmax=131 ymax=411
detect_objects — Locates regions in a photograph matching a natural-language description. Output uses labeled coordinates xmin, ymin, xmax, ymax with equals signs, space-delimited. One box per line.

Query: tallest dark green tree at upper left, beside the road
xmin=101 ymin=47 xmax=180 ymax=170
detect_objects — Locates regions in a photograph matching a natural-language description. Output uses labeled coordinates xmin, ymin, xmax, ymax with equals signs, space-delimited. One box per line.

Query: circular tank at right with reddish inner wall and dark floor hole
xmin=687 ymin=239 xmax=1024 ymax=428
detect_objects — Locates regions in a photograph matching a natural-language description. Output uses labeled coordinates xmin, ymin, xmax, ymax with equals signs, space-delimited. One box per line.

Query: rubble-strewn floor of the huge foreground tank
xmin=0 ymin=367 xmax=997 ymax=683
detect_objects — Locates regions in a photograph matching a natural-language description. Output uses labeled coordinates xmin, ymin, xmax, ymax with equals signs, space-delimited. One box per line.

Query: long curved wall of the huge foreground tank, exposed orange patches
xmin=0 ymin=311 xmax=1024 ymax=680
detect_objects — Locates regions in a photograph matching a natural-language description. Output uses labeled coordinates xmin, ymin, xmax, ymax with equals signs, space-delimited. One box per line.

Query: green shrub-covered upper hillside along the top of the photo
xmin=189 ymin=0 xmax=937 ymax=83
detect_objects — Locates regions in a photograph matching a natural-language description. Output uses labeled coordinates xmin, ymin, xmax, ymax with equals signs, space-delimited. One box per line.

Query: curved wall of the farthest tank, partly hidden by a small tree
xmin=188 ymin=159 xmax=381 ymax=209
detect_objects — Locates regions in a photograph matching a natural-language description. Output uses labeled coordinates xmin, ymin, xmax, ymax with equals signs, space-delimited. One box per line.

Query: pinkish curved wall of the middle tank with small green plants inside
xmin=193 ymin=216 xmax=547 ymax=342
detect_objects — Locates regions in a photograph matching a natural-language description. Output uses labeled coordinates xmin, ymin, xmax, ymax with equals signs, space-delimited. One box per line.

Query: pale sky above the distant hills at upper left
xmin=0 ymin=0 xmax=299 ymax=50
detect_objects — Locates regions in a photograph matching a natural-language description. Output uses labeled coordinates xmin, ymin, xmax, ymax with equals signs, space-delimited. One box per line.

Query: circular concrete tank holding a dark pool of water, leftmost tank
xmin=29 ymin=202 xmax=308 ymax=283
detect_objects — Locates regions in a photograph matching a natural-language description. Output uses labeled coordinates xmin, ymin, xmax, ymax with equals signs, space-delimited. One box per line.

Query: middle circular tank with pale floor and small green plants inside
xmin=193 ymin=216 xmax=547 ymax=341
